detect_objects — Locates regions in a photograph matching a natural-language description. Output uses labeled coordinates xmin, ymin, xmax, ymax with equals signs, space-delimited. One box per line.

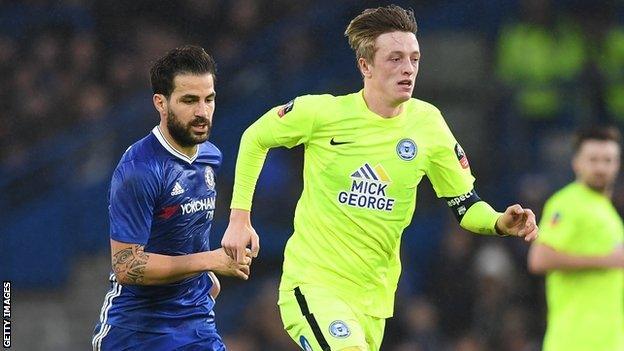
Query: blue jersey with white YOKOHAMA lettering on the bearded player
xmin=100 ymin=127 xmax=221 ymax=332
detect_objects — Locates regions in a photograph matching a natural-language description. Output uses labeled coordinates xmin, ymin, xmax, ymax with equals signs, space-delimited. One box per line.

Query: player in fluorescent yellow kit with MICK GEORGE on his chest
xmin=222 ymin=6 xmax=537 ymax=350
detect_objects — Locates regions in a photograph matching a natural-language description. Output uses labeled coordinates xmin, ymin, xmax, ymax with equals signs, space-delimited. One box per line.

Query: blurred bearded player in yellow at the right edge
xmin=528 ymin=127 xmax=624 ymax=351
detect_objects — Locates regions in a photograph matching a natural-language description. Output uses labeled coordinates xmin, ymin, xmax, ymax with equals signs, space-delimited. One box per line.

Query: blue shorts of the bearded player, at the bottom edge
xmin=91 ymin=323 xmax=226 ymax=351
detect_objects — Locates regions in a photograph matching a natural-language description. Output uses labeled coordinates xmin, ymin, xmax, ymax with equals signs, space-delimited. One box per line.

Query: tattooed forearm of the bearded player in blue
xmin=112 ymin=245 xmax=216 ymax=285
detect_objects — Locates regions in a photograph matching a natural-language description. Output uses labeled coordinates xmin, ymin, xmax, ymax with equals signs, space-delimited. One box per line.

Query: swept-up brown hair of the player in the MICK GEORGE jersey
xmin=345 ymin=5 xmax=418 ymax=62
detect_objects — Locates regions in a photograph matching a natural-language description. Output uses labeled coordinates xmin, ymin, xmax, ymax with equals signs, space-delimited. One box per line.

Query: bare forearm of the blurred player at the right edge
xmin=528 ymin=243 xmax=617 ymax=274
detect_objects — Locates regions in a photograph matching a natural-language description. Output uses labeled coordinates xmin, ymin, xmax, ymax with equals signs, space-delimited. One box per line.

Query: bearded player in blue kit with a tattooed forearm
xmin=92 ymin=46 xmax=251 ymax=351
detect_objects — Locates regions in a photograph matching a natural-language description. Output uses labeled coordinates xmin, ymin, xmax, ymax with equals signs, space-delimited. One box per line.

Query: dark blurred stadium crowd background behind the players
xmin=0 ymin=0 xmax=624 ymax=351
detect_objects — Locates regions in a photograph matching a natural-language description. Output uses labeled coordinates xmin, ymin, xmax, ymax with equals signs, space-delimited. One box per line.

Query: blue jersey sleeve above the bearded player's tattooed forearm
xmin=109 ymin=161 xmax=159 ymax=245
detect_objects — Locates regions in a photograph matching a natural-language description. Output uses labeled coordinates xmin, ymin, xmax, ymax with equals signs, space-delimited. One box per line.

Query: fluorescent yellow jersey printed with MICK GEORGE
xmin=231 ymin=91 xmax=474 ymax=318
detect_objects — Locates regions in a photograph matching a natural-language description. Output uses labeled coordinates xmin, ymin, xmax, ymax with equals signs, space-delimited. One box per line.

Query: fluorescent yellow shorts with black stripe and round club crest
xmin=278 ymin=285 xmax=386 ymax=351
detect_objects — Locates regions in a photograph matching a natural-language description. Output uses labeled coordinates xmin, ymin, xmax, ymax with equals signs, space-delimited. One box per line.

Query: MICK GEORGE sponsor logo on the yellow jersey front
xmin=338 ymin=163 xmax=395 ymax=211
